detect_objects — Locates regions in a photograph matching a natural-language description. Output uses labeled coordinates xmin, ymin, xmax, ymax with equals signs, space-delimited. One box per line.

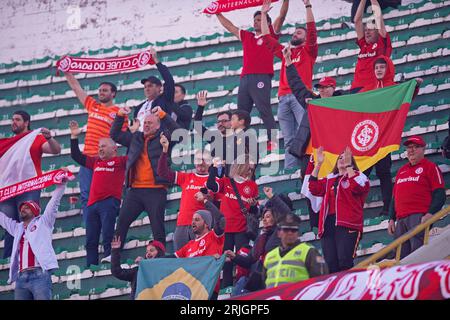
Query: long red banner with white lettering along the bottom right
xmin=234 ymin=260 xmax=450 ymax=300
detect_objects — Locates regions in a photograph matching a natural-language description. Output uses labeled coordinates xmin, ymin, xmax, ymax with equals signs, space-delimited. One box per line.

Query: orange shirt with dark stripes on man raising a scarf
xmin=83 ymin=96 xmax=128 ymax=157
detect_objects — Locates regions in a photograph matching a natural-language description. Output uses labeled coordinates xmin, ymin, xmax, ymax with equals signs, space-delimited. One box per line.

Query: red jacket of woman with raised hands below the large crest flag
xmin=309 ymin=171 xmax=370 ymax=238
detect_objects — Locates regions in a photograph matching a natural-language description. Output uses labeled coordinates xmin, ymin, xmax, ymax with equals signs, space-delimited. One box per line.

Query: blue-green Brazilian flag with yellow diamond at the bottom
xmin=136 ymin=255 xmax=225 ymax=300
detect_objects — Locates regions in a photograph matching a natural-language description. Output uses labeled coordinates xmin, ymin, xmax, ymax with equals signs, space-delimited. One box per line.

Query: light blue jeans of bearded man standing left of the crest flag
xmin=277 ymin=94 xmax=306 ymax=169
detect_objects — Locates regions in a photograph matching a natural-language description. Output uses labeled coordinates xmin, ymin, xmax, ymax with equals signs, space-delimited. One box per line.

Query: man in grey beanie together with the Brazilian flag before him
xmin=136 ymin=188 xmax=225 ymax=300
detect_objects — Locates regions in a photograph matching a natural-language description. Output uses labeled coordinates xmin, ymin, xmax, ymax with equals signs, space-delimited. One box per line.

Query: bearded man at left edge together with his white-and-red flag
xmin=0 ymin=110 xmax=61 ymax=259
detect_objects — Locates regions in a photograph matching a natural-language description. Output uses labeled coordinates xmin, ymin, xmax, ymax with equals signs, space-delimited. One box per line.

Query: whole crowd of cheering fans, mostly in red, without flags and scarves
xmin=0 ymin=0 xmax=445 ymax=299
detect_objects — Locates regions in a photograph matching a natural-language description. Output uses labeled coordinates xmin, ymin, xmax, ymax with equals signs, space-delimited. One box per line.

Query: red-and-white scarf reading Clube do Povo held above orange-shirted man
xmin=56 ymin=50 xmax=155 ymax=73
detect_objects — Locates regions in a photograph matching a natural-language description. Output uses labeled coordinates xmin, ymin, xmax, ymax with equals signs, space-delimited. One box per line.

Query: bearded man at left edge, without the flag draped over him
xmin=0 ymin=110 xmax=61 ymax=259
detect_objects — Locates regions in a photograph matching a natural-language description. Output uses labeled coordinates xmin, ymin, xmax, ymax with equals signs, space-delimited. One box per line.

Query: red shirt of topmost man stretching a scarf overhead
xmin=239 ymin=26 xmax=279 ymax=78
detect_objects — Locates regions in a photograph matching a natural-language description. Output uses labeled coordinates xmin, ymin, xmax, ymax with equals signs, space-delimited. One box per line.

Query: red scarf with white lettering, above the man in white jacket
xmin=0 ymin=169 xmax=75 ymax=202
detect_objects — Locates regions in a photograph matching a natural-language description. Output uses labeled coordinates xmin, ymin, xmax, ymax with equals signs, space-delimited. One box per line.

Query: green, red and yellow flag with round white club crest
xmin=308 ymin=80 xmax=416 ymax=177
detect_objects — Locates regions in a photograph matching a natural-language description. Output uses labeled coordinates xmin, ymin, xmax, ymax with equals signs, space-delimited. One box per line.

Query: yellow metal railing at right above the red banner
xmin=354 ymin=206 xmax=450 ymax=269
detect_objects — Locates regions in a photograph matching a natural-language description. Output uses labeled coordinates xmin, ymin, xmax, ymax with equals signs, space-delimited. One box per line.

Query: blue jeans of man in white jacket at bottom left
xmin=14 ymin=268 xmax=52 ymax=300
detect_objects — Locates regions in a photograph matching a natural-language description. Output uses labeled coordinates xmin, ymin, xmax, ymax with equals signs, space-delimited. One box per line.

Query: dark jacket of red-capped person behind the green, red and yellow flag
xmin=286 ymin=64 xmax=361 ymax=157
